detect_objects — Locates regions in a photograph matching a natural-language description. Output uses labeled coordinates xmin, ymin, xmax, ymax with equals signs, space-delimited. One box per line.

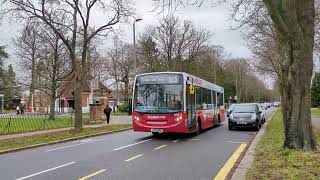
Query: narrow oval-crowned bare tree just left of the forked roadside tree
xmin=36 ymin=25 xmax=72 ymax=119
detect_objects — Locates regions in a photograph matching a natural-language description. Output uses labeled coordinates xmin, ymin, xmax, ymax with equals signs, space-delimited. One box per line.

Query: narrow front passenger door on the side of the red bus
xmin=186 ymin=84 xmax=196 ymax=130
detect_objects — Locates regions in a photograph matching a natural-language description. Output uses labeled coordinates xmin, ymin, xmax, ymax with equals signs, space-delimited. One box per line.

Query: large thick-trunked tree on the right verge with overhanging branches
xmin=154 ymin=0 xmax=317 ymax=150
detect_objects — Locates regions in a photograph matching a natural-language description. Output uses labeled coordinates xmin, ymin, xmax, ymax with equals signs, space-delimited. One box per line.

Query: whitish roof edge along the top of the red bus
xmin=136 ymin=71 xmax=224 ymax=93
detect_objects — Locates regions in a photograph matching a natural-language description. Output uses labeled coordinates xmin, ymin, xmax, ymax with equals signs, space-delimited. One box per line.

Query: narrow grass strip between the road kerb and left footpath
xmin=0 ymin=124 xmax=132 ymax=151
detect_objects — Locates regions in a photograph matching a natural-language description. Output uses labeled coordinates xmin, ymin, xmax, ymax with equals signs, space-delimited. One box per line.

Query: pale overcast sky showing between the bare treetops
xmin=0 ymin=0 xmax=251 ymax=68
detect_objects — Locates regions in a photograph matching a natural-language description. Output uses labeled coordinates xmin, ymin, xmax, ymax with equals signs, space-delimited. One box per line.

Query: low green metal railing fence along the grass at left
xmin=0 ymin=113 xmax=74 ymax=135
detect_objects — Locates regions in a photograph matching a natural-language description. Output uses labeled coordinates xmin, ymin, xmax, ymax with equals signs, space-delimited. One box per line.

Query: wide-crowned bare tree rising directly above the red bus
xmin=139 ymin=16 xmax=212 ymax=72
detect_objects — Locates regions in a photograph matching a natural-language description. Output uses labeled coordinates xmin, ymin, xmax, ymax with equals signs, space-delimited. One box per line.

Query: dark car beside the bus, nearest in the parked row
xmin=228 ymin=103 xmax=262 ymax=130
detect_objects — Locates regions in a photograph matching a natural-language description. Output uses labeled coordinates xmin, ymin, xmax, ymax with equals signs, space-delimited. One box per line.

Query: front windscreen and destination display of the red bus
xmin=134 ymin=74 xmax=183 ymax=113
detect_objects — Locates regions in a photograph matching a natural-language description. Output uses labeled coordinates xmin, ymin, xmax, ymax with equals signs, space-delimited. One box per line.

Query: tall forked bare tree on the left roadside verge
xmin=9 ymin=0 xmax=133 ymax=130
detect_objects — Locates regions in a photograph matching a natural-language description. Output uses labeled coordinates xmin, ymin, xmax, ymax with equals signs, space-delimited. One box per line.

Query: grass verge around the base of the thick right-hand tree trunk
xmin=246 ymin=110 xmax=320 ymax=180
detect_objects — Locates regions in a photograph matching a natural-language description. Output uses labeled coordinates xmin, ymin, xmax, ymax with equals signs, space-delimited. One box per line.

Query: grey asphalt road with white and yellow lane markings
xmin=0 ymin=107 xmax=272 ymax=180
